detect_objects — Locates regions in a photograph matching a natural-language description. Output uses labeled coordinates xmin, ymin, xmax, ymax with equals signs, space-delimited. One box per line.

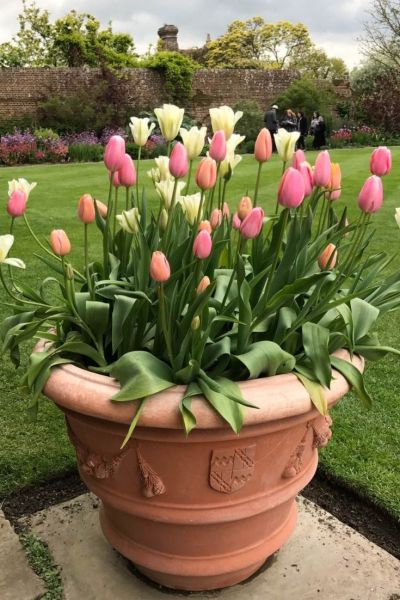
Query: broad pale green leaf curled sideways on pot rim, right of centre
xmin=232 ymin=341 xmax=296 ymax=379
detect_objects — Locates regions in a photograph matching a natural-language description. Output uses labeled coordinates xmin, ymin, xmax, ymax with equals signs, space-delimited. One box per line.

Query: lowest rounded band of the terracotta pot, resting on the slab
xmin=100 ymin=501 xmax=297 ymax=592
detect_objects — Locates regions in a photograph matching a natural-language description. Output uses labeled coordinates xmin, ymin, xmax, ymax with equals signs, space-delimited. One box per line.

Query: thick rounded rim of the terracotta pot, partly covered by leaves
xmin=39 ymin=341 xmax=364 ymax=429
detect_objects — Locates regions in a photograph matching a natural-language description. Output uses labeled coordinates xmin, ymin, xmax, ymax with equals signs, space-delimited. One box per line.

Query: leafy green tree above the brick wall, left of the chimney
xmin=0 ymin=0 xmax=137 ymax=68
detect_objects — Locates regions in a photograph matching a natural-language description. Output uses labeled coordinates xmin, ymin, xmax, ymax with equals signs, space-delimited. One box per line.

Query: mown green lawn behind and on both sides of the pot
xmin=0 ymin=148 xmax=400 ymax=517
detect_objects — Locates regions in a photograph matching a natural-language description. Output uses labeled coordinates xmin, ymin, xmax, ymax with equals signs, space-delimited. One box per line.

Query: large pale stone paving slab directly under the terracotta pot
xmin=18 ymin=494 xmax=400 ymax=600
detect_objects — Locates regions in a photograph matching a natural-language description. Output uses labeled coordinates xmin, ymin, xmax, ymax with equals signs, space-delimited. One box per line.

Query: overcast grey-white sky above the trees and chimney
xmin=0 ymin=0 xmax=368 ymax=67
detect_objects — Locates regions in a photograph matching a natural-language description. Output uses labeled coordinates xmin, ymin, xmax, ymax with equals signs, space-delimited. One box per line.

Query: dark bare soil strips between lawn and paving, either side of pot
xmin=0 ymin=470 xmax=400 ymax=559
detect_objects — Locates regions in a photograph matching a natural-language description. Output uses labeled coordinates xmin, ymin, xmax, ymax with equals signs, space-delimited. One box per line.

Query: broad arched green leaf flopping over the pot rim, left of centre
xmin=108 ymin=350 xmax=175 ymax=402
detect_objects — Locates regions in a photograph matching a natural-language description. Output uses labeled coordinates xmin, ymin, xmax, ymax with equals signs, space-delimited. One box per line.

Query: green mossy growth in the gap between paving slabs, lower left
xmin=19 ymin=532 xmax=63 ymax=600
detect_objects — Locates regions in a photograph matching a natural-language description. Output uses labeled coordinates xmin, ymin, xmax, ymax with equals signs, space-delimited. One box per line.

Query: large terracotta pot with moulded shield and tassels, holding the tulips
xmin=45 ymin=351 xmax=363 ymax=591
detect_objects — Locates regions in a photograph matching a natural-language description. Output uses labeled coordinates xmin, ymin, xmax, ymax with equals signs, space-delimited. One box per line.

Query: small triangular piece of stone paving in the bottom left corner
xmin=0 ymin=511 xmax=45 ymax=600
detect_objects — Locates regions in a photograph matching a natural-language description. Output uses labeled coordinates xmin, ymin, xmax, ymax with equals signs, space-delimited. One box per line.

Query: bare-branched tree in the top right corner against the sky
xmin=362 ymin=0 xmax=400 ymax=69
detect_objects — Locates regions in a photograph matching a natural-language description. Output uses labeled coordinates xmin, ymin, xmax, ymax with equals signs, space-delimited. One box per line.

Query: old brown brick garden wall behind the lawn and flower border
xmin=0 ymin=68 xmax=346 ymax=122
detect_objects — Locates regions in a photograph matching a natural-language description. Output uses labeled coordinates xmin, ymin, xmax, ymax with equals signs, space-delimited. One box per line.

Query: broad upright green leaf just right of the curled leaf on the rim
xmin=302 ymin=323 xmax=332 ymax=388
